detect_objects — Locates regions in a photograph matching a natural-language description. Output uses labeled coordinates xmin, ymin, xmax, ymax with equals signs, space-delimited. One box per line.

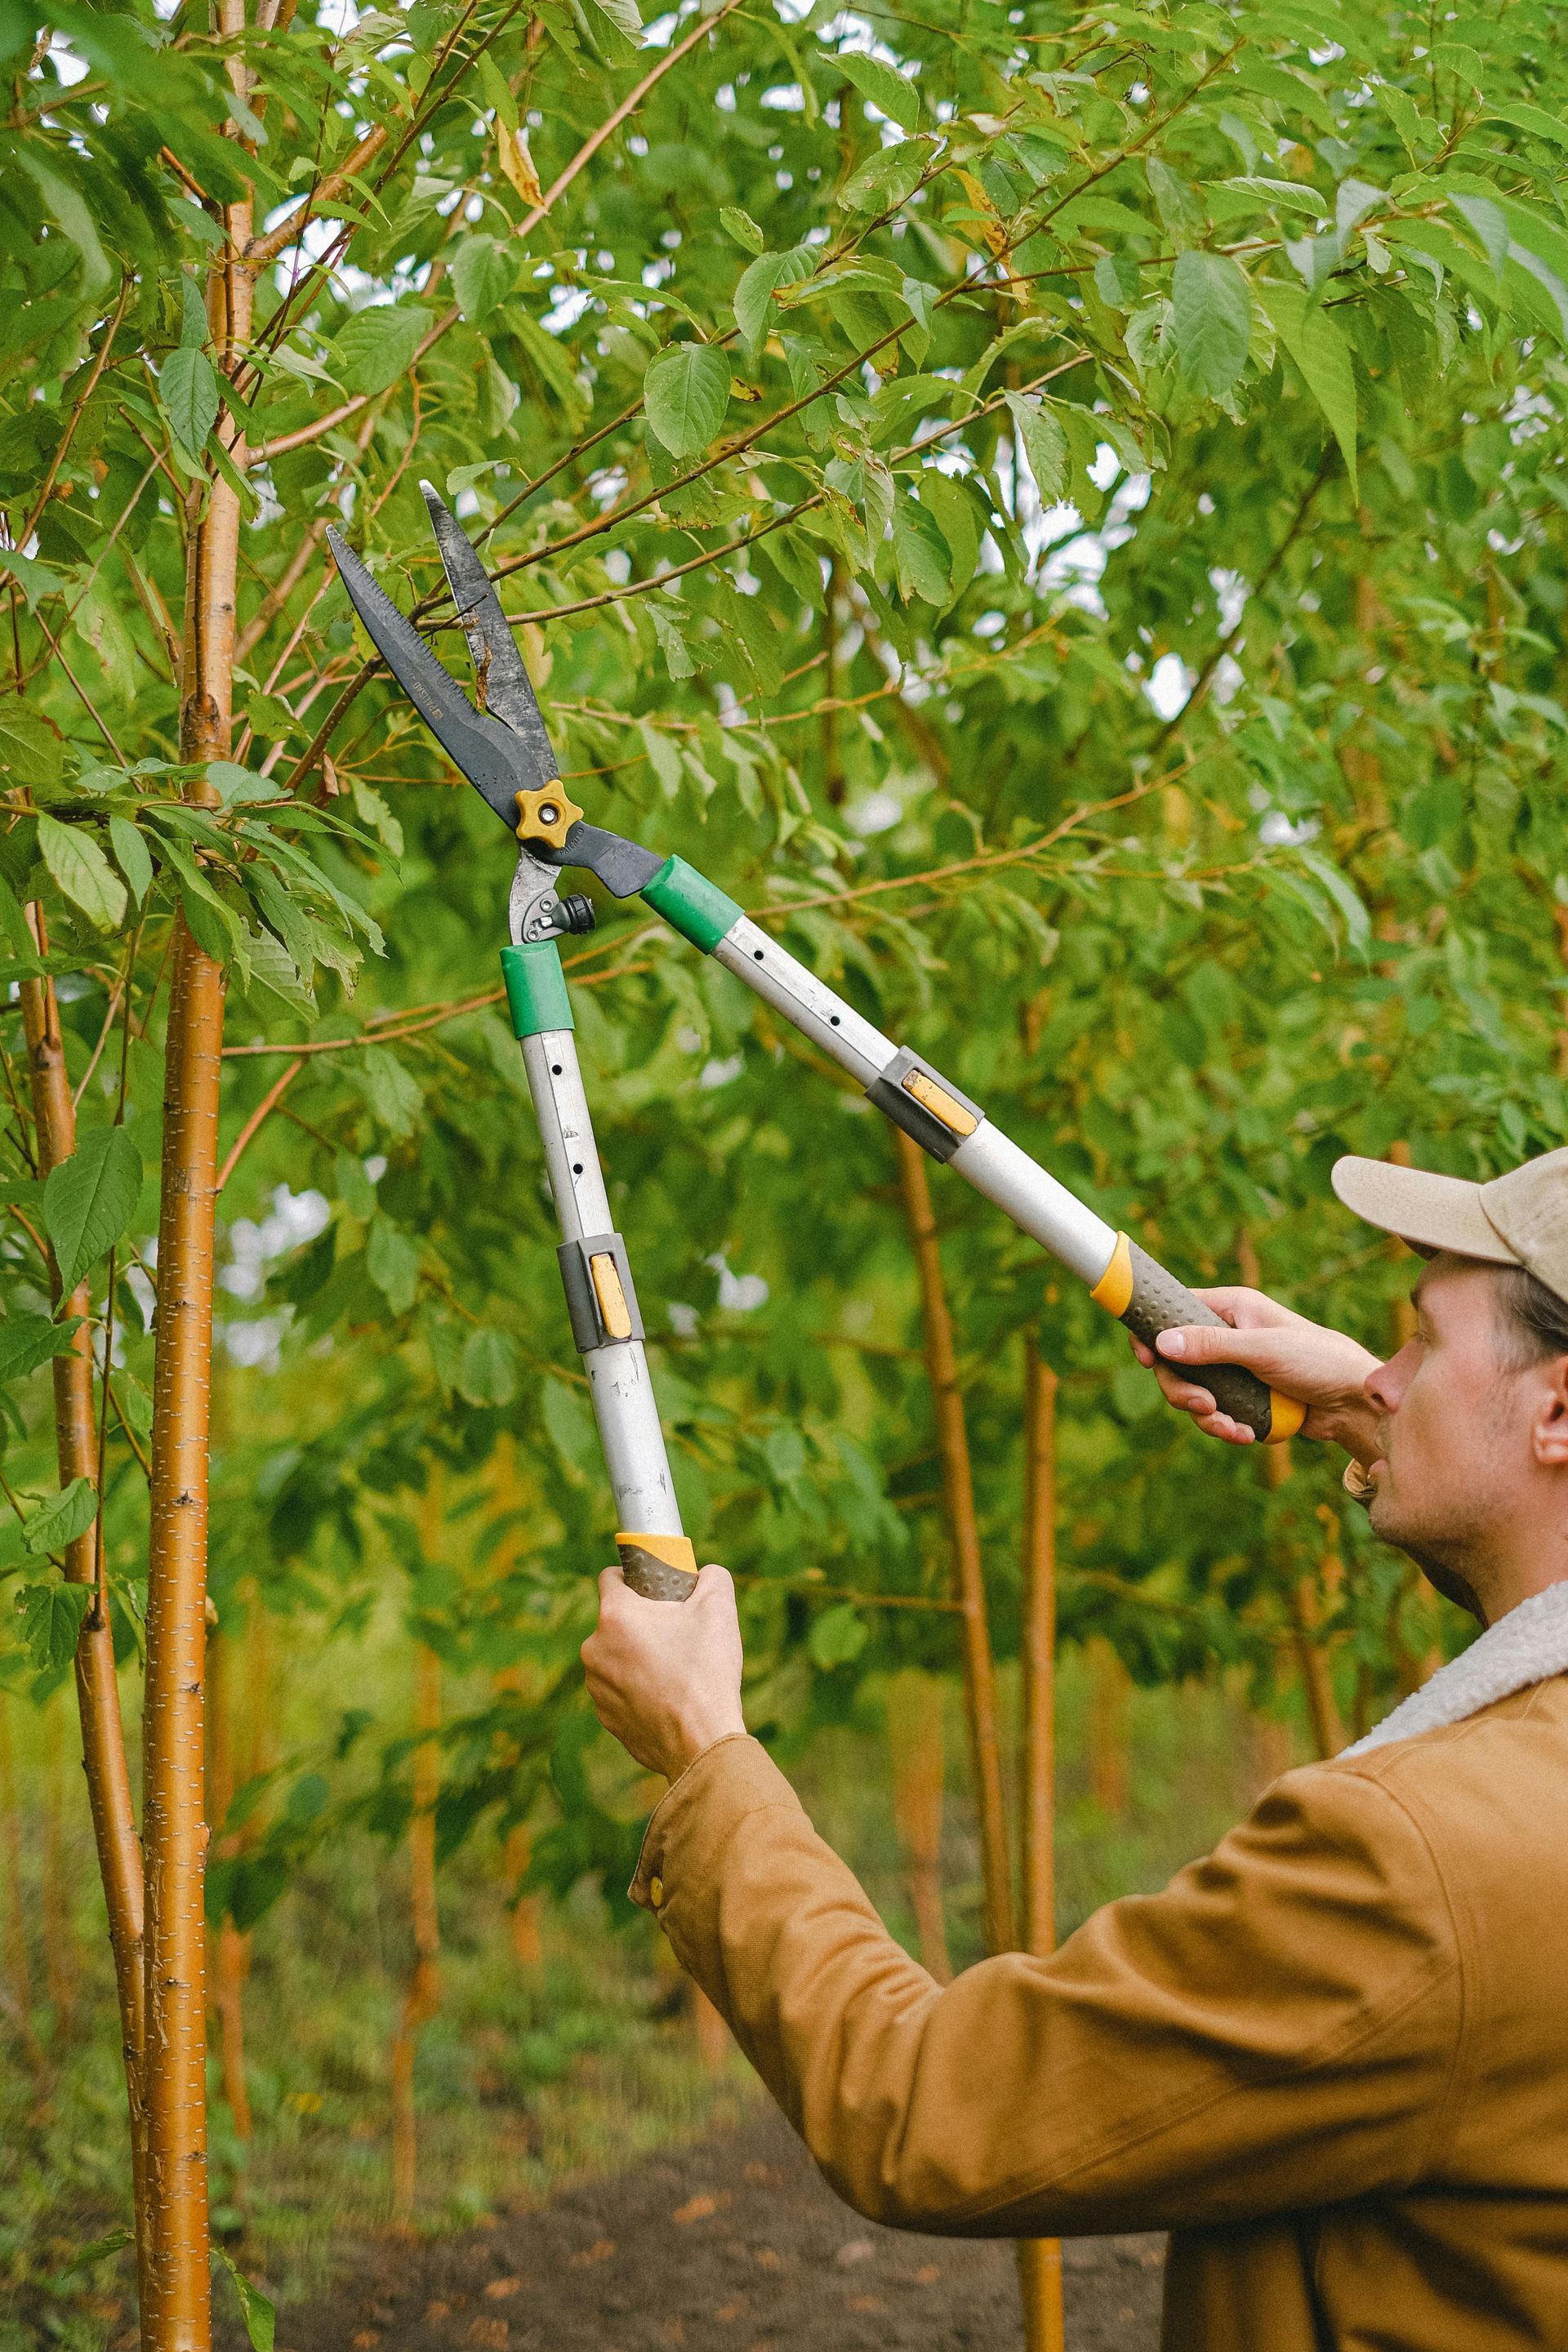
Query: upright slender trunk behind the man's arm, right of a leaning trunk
xmin=1018 ymin=1341 xmax=1067 ymax=2352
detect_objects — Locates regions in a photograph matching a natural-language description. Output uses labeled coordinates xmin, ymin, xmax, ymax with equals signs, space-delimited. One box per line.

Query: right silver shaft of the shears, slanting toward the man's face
xmin=642 ymin=858 xmax=1305 ymax=1441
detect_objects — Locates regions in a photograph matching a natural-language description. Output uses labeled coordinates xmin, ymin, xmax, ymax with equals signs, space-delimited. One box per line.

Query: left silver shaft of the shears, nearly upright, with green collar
xmin=501 ymin=941 xmax=696 ymax=1601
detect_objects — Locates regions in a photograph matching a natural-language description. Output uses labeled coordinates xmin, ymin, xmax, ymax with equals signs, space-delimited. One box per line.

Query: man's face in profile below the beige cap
xmin=1365 ymin=1256 xmax=1533 ymax=1620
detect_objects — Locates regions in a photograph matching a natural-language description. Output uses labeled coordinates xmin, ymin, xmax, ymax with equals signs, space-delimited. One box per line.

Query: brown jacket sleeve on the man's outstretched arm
xmin=632 ymin=1735 xmax=1462 ymax=2237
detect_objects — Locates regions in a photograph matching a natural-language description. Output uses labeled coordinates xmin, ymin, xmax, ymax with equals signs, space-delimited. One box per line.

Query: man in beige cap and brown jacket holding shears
xmin=583 ymin=1150 xmax=1568 ymax=2352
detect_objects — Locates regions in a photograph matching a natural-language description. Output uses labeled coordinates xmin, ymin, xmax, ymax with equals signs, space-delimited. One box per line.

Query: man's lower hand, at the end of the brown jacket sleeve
xmin=583 ymin=1564 xmax=746 ymax=1780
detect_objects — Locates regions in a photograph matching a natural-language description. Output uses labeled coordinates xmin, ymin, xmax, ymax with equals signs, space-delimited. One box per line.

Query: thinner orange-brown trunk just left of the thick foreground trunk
xmin=21 ymin=941 xmax=145 ymax=2182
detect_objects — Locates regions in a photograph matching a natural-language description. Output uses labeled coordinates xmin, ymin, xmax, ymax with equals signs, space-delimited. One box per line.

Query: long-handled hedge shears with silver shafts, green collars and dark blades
xmin=327 ymin=482 xmax=1303 ymax=1599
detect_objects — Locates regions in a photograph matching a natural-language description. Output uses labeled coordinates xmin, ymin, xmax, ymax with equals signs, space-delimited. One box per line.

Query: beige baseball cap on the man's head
xmin=1333 ymin=1150 xmax=1568 ymax=1298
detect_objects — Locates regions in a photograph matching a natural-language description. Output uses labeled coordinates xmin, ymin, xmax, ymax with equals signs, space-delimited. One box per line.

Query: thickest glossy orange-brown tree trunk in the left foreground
xmin=141 ymin=55 xmax=252 ymax=2352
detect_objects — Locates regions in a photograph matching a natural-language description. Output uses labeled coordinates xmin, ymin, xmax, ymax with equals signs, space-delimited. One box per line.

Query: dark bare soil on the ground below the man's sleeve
xmin=257 ymin=2109 xmax=1164 ymax=2352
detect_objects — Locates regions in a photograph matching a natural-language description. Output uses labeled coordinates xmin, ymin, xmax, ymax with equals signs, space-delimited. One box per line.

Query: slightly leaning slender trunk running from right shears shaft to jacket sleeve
xmin=893 ymin=1129 xmax=1013 ymax=1952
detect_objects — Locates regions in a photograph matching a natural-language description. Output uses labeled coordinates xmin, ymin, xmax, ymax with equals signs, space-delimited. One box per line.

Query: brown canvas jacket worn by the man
xmin=632 ymin=1675 xmax=1568 ymax=2352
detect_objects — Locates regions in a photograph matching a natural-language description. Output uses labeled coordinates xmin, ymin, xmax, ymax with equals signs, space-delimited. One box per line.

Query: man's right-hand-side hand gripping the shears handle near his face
xmin=1133 ymin=1289 xmax=1378 ymax=1468
